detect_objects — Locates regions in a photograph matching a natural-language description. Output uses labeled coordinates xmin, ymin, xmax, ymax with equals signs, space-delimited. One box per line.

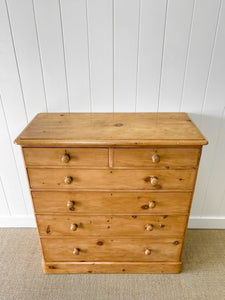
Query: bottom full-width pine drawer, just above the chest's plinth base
xmin=41 ymin=237 xmax=182 ymax=262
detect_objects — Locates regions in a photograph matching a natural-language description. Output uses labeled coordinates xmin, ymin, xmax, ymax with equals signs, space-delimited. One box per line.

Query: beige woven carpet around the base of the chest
xmin=0 ymin=229 xmax=225 ymax=300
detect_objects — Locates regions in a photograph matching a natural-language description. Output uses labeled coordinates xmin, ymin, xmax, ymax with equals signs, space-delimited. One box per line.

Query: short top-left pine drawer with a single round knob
xmin=23 ymin=148 xmax=109 ymax=167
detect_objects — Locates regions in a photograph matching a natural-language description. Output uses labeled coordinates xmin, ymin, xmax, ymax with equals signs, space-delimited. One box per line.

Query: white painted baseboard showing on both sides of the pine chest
xmin=0 ymin=215 xmax=225 ymax=229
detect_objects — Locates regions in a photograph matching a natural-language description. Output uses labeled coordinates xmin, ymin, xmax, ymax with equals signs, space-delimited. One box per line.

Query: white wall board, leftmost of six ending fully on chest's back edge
xmin=34 ymin=0 xmax=69 ymax=112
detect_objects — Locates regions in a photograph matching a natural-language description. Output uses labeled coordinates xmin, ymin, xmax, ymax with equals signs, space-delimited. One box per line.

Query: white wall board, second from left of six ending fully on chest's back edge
xmin=60 ymin=0 xmax=91 ymax=112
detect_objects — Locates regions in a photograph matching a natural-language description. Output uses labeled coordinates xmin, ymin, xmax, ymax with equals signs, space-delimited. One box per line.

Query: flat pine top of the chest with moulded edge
xmin=15 ymin=113 xmax=208 ymax=147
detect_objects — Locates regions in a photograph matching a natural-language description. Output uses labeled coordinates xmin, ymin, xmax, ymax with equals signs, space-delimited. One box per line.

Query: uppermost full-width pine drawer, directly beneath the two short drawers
xmin=28 ymin=169 xmax=196 ymax=190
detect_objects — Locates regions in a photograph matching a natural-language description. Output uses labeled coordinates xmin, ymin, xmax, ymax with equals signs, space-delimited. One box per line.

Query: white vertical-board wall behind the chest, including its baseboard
xmin=0 ymin=0 xmax=225 ymax=228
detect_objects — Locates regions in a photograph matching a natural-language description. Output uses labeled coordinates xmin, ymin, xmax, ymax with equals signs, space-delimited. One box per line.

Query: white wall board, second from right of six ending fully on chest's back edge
xmin=136 ymin=0 xmax=167 ymax=112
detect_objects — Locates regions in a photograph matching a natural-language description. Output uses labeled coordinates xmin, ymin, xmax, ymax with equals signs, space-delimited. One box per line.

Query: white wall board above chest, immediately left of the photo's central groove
xmin=87 ymin=0 xmax=113 ymax=112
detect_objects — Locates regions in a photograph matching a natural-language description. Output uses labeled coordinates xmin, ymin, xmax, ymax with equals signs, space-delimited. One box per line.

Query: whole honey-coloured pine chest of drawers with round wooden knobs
xmin=16 ymin=113 xmax=207 ymax=273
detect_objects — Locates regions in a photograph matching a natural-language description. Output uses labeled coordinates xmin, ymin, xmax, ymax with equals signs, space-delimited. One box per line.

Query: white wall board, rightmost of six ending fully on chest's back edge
xmin=159 ymin=0 xmax=194 ymax=111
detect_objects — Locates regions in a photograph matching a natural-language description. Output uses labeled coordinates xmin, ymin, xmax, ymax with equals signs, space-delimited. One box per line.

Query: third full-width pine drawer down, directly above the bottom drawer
xmin=37 ymin=215 xmax=187 ymax=237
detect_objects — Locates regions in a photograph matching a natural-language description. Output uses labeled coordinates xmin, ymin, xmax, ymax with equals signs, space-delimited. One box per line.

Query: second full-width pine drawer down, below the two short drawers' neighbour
xmin=32 ymin=191 xmax=191 ymax=215
